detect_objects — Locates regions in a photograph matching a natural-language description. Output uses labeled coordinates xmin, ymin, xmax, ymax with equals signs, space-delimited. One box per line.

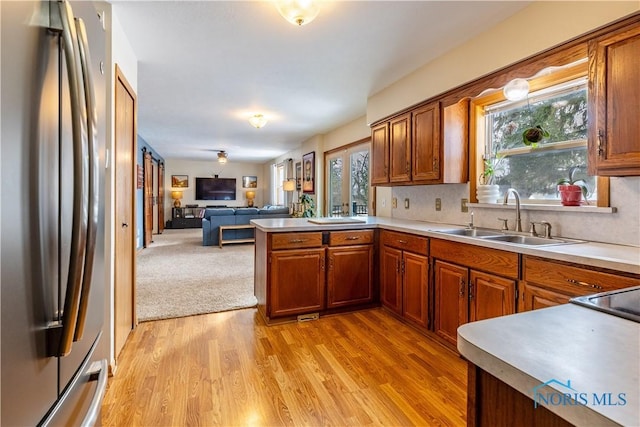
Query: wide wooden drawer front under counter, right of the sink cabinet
xmin=524 ymin=256 xmax=640 ymax=296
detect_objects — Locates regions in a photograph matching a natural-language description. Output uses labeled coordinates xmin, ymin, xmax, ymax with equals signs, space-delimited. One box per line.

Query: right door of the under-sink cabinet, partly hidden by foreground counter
xmin=469 ymin=270 xmax=516 ymax=322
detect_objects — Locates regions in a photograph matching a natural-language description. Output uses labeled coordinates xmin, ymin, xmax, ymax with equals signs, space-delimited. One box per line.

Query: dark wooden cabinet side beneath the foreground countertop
xmin=467 ymin=362 xmax=572 ymax=427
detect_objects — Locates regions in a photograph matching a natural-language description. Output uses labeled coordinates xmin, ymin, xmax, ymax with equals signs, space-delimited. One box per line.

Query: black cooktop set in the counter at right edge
xmin=571 ymin=286 xmax=640 ymax=323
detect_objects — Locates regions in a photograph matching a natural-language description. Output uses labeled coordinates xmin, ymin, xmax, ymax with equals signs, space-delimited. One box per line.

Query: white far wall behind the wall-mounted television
xmin=164 ymin=159 xmax=269 ymax=220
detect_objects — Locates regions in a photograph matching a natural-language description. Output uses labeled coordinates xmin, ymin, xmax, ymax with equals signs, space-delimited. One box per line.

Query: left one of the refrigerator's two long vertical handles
xmin=47 ymin=0 xmax=89 ymax=356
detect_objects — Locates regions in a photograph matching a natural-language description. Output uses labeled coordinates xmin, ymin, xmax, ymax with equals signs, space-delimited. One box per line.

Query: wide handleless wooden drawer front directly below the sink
xmin=431 ymin=239 xmax=518 ymax=279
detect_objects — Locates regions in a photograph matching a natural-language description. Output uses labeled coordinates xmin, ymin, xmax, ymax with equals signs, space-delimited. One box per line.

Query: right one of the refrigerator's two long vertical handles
xmin=73 ymin=18 xmax=100 ymax=341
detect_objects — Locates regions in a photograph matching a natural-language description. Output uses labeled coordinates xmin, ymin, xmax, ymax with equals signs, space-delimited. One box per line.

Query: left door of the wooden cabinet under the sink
xmin=434 ymin=261 xmax=468 ymax=345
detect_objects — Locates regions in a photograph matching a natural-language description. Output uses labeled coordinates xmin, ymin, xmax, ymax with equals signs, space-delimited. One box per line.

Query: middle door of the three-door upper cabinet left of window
xmin=389 ymin=113 xmax=411 ymax=182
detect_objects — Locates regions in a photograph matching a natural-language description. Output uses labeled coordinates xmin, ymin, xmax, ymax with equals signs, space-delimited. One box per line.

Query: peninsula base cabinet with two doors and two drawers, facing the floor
xmin=255 ymin=229 xmax=378 ymax=322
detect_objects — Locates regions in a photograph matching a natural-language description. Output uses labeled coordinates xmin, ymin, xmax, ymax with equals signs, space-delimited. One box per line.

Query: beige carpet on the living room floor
xmin=136 ymin=229 xmax=257 ymax=321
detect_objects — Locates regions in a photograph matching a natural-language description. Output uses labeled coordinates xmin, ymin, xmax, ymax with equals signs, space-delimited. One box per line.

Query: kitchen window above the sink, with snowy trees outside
xmin=473 ymin=64 xmax=598 ymax=204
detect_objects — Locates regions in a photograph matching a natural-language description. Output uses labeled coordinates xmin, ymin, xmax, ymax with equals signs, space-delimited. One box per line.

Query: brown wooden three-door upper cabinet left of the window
xmin=371 ymin=100 xmax=469 ymax=185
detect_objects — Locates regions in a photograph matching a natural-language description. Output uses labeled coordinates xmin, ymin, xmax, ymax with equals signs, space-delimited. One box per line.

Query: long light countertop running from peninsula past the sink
xmin=251 ymin=217 xmax=640 ymax=274
